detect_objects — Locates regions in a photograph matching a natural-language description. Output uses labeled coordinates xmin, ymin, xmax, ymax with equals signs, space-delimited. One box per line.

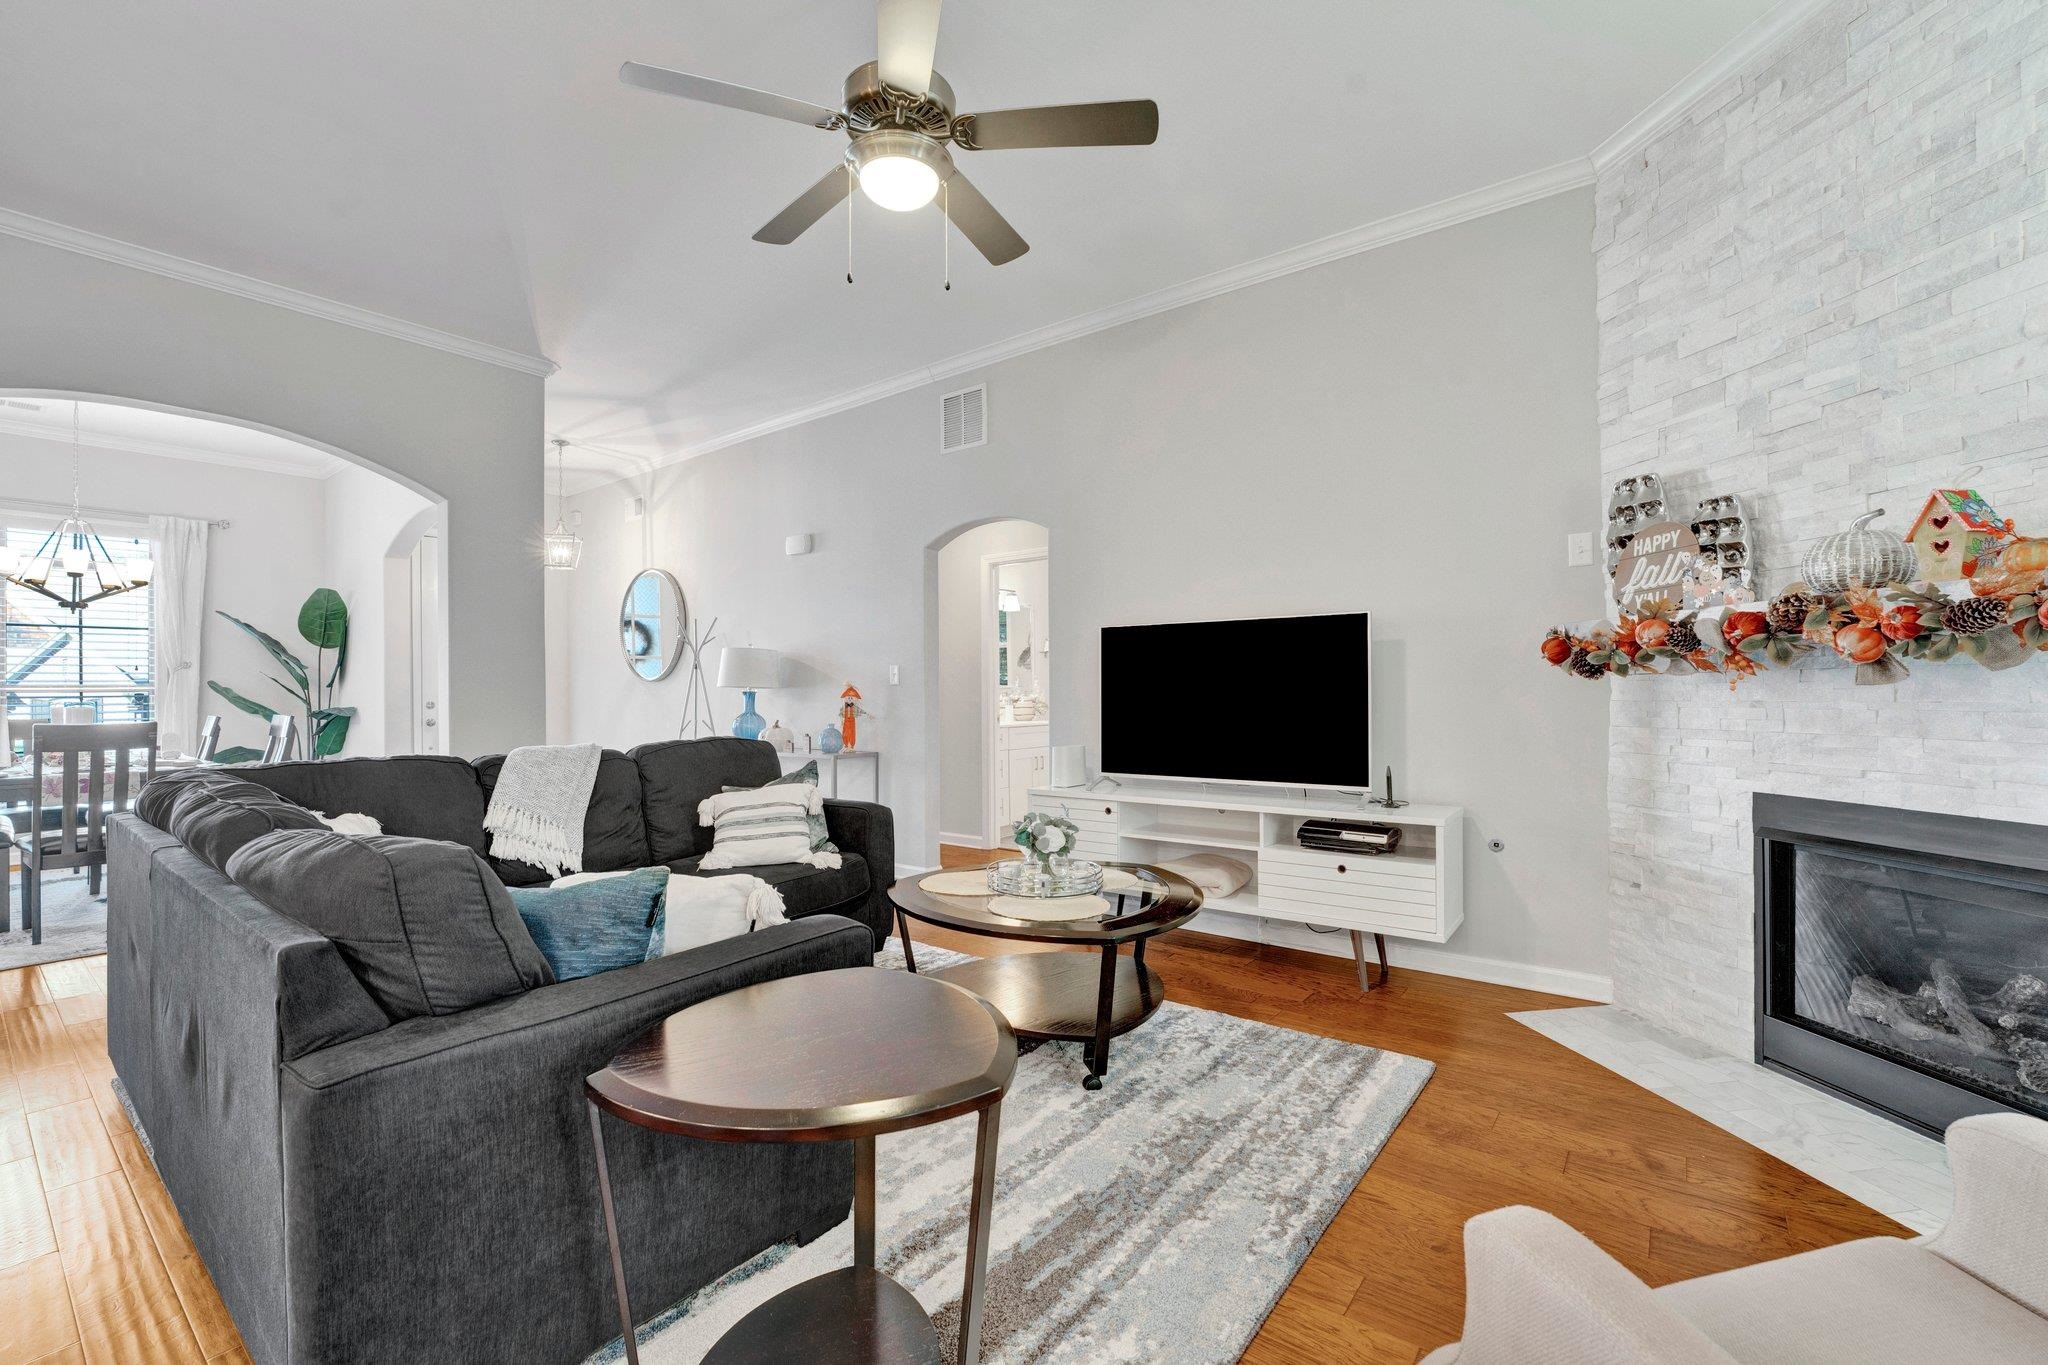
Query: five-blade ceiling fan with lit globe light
xmin=618 ymin=0 xmax=1159 ymax=266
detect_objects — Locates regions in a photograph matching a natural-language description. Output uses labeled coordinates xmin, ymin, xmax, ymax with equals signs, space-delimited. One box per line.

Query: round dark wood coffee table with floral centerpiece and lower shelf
xmin=889 ymin=864 xmax=1202 ymax=1091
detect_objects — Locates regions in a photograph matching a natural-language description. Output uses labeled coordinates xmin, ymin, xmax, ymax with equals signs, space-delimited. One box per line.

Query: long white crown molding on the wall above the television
xmin=645 ymin=158 xmax=1593 ymax=469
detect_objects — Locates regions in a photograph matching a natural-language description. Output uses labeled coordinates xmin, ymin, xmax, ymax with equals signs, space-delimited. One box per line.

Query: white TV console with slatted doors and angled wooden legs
xmin=1030 ymin=784 xmax=1464 ymax=990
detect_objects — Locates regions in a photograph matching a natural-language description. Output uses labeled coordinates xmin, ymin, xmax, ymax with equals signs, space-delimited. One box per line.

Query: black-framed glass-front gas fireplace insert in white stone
xmin=1753 ymin=796 xmax=2048 ymax=1134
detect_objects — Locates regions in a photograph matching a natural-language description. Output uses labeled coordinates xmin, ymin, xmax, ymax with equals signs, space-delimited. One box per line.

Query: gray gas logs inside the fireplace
xmin=1849 ymin=958 xmax=2048 ymax=1095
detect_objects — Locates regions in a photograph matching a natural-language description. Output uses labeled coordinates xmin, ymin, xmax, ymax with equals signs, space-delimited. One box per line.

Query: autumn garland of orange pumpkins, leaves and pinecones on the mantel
xmin=1542 ymin=573 xmax=2048 ymax=688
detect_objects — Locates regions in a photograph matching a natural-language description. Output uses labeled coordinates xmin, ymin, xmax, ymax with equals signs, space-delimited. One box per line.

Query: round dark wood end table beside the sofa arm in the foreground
xmin=584 ymin=966 xmax=1018 ymax=1365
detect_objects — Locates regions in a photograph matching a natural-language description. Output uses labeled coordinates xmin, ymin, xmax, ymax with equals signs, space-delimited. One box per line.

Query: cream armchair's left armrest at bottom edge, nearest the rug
xmin=1432 ymin=1205 xmax=1733 ymax=1365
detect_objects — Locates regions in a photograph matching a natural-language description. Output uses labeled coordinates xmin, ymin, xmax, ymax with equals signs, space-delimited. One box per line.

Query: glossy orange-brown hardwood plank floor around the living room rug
xmin=0 ymin=849 xmax=1905 ymax=1365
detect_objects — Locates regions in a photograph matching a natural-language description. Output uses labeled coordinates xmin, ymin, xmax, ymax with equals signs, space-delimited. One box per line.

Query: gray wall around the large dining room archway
xmin=0 ymin=237 xmax=543 ymax=753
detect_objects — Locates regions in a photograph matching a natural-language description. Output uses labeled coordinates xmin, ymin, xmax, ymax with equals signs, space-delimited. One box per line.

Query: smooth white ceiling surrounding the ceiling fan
xmin=0 ymin=0 xmax=1772 ymax=485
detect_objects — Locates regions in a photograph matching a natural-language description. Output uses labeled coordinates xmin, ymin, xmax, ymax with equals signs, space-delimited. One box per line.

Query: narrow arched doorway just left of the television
xmin=926 ymin=518 xmax=1057 ymax=855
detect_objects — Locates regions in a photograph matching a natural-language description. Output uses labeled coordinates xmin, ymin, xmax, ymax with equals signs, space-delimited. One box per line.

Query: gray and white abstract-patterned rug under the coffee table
xmin=592 ymin=943 xmax=1434 ymax=1365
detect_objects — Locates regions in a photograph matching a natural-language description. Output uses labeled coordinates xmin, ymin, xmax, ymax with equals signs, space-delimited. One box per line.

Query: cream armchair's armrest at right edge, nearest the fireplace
xmin=1925 ymin=1113 xmax=2048 ymax=1316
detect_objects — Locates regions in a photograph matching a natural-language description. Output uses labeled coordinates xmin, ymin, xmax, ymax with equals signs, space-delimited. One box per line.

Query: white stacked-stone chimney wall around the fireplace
xmin=1597 ymin=0 xmax=2048 ymax=1056
